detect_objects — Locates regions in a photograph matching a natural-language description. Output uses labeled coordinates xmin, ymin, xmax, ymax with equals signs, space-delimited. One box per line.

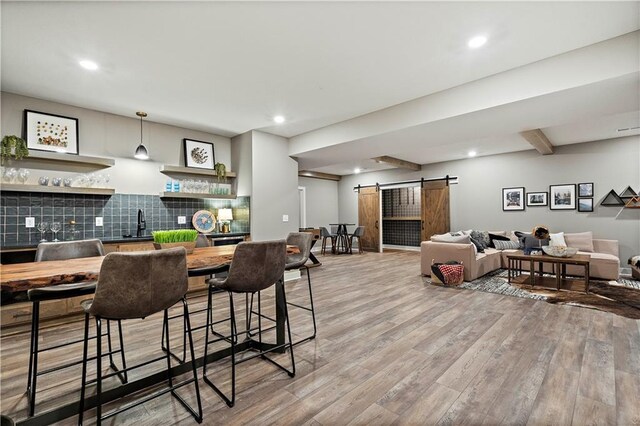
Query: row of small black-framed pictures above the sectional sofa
xmin=502 ymin=182 xmax=594 ymax=212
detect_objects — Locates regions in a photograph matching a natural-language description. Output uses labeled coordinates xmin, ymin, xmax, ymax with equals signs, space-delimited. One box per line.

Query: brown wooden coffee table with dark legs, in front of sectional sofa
xmin=507 ymin=254 xmax=590 ymax=293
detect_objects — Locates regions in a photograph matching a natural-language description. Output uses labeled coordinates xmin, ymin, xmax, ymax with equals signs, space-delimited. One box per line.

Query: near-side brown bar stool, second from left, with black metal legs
xmin=202 ymin=240 xmax=296 ymax=407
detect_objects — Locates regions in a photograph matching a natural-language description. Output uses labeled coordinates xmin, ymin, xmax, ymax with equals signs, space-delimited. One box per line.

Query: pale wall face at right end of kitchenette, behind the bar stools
xmin=251 ymin=131 xmax=299 ymax=241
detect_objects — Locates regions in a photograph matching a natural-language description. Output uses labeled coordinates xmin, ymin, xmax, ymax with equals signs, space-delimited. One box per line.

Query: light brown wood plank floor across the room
xmin=0 ymin=251 xmax=640 ymax=426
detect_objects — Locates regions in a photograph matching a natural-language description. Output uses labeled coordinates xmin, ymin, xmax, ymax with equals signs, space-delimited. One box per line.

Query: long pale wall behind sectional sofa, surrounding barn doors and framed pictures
xmin=338 ymin=136 xmax=640 ymax=264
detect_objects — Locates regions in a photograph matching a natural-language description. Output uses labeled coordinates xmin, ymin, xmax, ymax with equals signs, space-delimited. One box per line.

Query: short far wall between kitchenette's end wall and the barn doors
xmin=298 ymin=177 xmax=339 ymax=228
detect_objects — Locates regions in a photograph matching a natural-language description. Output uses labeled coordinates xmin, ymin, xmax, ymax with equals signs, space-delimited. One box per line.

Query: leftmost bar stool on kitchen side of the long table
xmin=27 ymin=239 xmax=127 ymax=417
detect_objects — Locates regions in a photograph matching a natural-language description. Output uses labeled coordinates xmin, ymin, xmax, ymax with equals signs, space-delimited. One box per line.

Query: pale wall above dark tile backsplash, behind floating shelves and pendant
xmin=0 ymin=92 xmax=235 ymax=194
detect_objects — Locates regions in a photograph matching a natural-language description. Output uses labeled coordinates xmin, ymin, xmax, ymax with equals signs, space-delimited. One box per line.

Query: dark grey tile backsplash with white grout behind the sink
xmin=0 ymin=192 xmax=250 ymax=247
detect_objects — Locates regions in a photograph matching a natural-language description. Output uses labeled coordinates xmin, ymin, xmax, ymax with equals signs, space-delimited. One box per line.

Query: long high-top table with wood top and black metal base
xmin=0 ymin=245 xmax=300 ymax=425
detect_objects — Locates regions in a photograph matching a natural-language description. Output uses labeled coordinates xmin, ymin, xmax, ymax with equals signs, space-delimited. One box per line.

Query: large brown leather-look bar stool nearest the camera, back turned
xmin=78 ymin=247 xmax=202 ymax=425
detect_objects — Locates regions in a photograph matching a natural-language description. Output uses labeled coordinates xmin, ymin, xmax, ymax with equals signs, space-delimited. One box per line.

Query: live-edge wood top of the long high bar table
xmin=0 ymin=245 xmax=299 ymax=293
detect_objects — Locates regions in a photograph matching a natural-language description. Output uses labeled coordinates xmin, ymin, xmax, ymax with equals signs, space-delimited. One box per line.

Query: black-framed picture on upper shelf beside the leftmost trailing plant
xmin=24 ymin=109 xmax=80 ymax=155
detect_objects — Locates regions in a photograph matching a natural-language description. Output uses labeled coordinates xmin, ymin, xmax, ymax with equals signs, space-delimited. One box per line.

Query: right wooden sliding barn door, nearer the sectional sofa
xmin=421 ymin=182 xmax=451 ymax=241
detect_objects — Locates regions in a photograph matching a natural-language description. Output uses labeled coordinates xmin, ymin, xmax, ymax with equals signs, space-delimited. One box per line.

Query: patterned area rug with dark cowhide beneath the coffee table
xmin=425 ymin=269 xmax=640 ymax=319
